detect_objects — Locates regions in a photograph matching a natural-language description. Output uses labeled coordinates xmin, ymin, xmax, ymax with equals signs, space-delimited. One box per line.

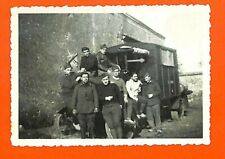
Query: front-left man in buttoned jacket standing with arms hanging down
xmin=72 ymin=72 xmax=99 ymax=139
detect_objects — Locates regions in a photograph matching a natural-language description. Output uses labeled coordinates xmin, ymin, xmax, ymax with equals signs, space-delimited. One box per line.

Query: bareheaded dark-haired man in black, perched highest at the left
xmin=80 ymin=47 xmax=98 ymax=77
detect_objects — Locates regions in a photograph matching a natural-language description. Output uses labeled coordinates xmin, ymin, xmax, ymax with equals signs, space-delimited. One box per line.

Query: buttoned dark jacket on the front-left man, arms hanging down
xmin=72 ymin=83 xmax=99 ymax=114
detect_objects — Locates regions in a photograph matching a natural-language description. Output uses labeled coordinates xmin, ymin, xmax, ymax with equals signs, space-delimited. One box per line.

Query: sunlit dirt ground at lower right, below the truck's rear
xmin=139 ymin=101 xmax=203 ymax=138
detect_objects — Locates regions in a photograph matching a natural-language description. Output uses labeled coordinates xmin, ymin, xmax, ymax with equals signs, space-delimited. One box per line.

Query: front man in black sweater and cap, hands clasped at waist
xmin=98 ymin=73 xmax=122 ymax=138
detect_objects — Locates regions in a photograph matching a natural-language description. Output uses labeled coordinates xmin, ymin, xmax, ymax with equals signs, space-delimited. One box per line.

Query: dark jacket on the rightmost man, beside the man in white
xmin=141 ymin=81 xmax=161 ymax=106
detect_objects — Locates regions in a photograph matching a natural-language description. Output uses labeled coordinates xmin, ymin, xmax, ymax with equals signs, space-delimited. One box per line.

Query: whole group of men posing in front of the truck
xmin=60 ymin=44 xmax=162 ymax=138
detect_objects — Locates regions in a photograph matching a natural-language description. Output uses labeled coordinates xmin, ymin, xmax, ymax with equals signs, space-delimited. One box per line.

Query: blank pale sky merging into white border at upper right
xmin=127 ymin=5 xmax=210 ymax=73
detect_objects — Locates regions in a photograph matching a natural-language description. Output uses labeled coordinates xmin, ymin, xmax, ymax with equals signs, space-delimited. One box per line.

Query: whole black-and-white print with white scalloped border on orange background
xmin=11 ymin=5 xmax=210 ymax=146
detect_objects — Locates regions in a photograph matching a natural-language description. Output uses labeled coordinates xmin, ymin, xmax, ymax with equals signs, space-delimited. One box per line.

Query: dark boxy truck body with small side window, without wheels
xmin=107 ymin=42 xmax=180 ymax=100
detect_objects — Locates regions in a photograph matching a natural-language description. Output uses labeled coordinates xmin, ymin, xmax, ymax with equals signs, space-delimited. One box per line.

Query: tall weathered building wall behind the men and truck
xmin=19 ymin=14 xmax=164 ymax=128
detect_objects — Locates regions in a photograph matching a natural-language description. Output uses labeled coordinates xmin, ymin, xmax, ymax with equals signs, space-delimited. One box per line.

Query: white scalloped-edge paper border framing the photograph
xmin=11 ymin=5 xmax=210 ymax=146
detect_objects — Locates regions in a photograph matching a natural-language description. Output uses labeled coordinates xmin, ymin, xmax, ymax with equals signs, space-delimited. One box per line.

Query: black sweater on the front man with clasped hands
xmin=97 ymin=83 xmax=123 ymax=106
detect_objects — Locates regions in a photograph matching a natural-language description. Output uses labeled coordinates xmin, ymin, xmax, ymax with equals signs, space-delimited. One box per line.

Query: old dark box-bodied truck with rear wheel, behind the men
xmin=107 ymin=42 xmax=191 ymax=119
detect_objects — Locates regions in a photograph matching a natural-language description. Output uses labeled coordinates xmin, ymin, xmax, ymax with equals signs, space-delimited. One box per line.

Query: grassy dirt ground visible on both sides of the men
xmin=20 ymin=95 xmax=203 ymax=139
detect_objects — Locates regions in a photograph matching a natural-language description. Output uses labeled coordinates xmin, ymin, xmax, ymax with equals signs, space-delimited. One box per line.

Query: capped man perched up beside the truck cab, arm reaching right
xmin=97 ymin=44 xmax=117 ymax=75
